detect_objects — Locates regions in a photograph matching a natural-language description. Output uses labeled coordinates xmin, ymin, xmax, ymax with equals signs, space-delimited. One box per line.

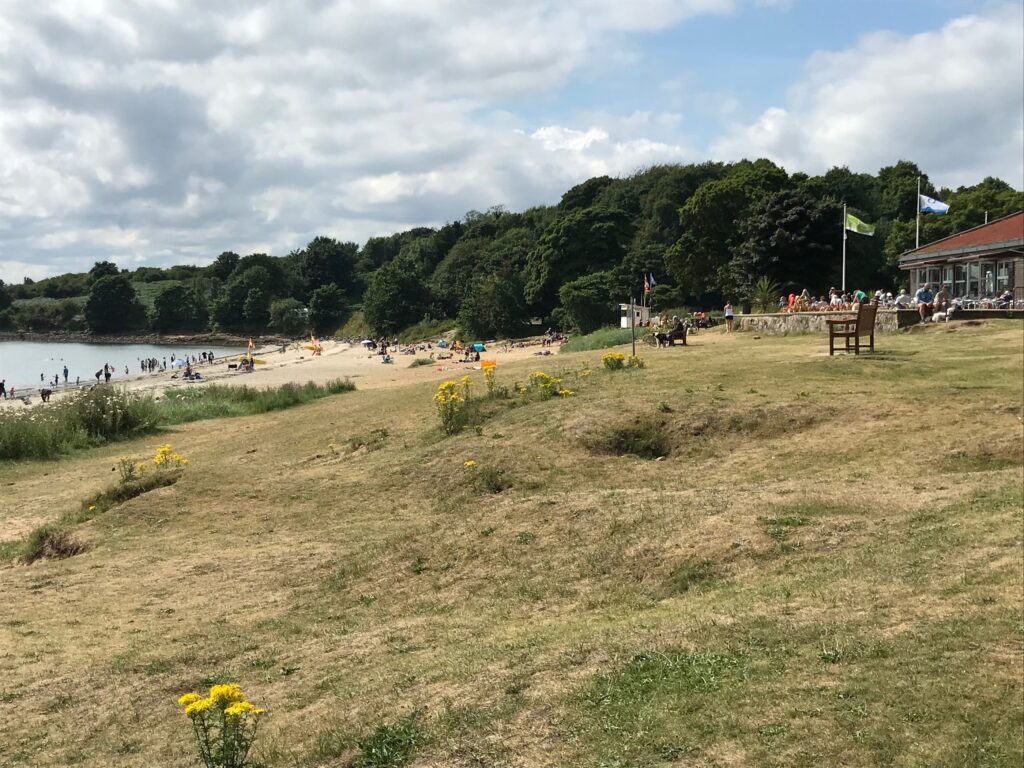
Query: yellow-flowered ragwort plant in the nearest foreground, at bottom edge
xmin=178 ymin=683 xmax=264 ymax=768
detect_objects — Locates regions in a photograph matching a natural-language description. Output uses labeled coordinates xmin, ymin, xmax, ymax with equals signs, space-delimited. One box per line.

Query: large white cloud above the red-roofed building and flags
xmin=713 ymin=6 xmax=1024 ymax=187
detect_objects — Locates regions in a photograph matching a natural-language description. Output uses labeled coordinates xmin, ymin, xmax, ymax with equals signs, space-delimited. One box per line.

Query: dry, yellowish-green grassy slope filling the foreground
xmin=0 ymin=322 xmax=1024 ymax=768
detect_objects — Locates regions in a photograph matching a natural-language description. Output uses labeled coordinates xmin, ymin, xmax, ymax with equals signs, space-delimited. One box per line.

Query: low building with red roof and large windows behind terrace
xmin=899 ymin=211 xmax=1024 ymax=301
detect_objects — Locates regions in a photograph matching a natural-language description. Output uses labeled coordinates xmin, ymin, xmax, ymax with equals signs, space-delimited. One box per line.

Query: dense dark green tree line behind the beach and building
xmin=0 ymin=160 xmax=1024 ymax=337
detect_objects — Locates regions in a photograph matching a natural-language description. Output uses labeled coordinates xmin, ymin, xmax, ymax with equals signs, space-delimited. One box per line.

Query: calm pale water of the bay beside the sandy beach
xmin=0 ymin=341 xmax=246 ymax=389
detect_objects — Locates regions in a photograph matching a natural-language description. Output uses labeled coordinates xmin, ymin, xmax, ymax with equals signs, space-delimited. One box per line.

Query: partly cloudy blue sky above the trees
xmin=0 ymin=0 xmax=1024 ymax=283
